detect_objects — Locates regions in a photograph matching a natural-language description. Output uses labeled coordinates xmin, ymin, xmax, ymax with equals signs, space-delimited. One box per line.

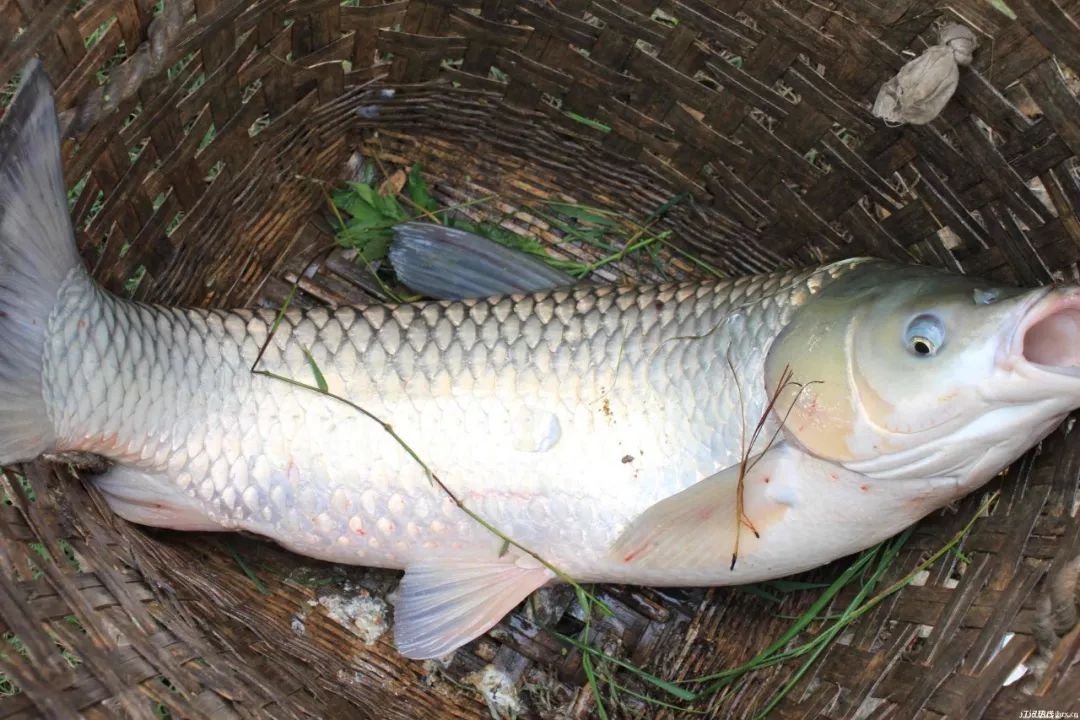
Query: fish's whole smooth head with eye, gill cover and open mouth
xmin=766 ymin=262 xmax=1080 ymax=491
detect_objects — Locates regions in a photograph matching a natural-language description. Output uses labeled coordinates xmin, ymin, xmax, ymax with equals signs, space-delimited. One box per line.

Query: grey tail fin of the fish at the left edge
xmin=0 ymin=60 xmax=82 ymax=464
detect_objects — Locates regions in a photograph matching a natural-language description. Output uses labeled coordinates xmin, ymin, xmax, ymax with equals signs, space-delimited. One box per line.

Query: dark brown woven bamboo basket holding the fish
xmin=0 ymin=0 xmax=1080 ymax=719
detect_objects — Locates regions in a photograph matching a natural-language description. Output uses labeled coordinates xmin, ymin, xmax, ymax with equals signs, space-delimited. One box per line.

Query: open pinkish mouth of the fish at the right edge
xmin=1014 ymin=290 xmax=1080 ymax=378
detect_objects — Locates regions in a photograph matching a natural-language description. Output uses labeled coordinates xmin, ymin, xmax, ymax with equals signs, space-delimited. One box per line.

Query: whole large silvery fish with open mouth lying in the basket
xmin=0 ymin=59 xmax=1080 ymax=658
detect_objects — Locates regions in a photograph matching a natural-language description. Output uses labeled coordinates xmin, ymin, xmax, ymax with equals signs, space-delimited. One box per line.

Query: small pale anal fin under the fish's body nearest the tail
xmin=91 ymin=465 xmax=231 ymax=531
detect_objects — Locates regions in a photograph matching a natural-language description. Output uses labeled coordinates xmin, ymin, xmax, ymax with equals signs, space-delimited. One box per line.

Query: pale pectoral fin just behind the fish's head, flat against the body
xmin=611 ymin=444 xmax=801 ymax=568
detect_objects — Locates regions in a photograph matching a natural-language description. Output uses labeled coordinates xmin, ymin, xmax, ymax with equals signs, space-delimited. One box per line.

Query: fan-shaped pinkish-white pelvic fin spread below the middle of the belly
xmin=394 ymin=557 xmax=552 ymax=660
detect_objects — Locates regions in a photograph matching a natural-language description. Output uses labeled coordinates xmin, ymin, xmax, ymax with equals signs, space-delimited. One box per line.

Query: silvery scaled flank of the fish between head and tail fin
xmin=44 ymin=263 xmax=851 ymax=578
